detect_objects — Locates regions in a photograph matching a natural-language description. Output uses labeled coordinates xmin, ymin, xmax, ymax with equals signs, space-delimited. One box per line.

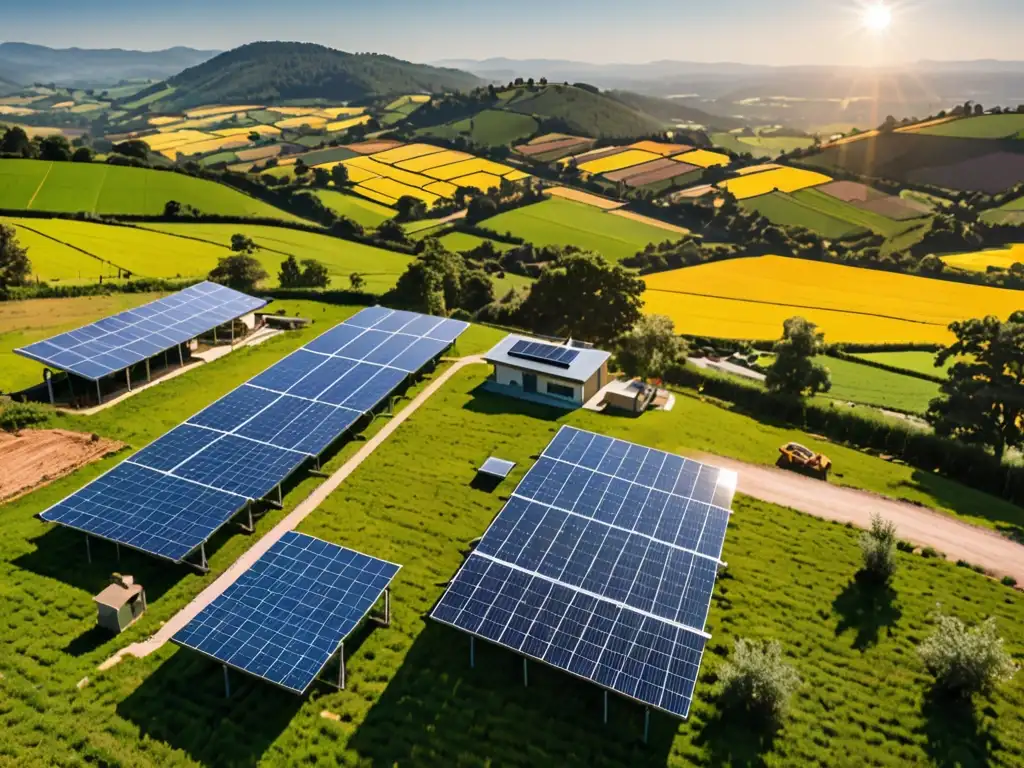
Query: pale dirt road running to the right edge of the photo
xmin=694 ymin=455 xmax=1024 ymax=584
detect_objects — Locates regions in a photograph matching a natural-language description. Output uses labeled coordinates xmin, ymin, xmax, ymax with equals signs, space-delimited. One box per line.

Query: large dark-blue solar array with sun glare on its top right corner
xmin=431 ymin=427 xmax=735 ymax=718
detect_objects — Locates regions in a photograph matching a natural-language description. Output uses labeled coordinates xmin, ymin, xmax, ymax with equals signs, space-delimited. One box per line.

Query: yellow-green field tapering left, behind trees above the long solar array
xmin=138 ymin=224 xmax=412 ymax=294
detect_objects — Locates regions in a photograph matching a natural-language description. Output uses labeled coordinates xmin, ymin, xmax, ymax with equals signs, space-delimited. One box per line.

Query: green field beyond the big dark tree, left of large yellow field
xmin=483 ymin=199 xmax=679 ymax=262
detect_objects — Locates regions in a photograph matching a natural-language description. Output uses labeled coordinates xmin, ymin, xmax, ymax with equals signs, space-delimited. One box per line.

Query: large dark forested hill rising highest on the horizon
xmin=147 ymin=42 xmax=481 ymax=110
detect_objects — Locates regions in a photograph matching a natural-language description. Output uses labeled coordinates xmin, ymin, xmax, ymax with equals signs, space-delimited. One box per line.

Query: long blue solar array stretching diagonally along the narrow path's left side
xmin=40 ymin=307 xmax=468 ymax=562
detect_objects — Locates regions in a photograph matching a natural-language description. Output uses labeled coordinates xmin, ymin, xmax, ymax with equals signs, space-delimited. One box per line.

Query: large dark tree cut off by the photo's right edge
xmin=927 ymin=311 xmax=1024 ymax=461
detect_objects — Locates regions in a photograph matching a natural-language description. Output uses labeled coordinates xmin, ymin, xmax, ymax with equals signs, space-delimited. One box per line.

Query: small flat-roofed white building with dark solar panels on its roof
xmin=483 ymin=334 xmax=611 ymax=409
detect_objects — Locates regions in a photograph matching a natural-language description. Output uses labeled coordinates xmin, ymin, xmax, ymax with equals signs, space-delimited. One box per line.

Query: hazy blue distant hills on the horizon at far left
xmin=0 ymin=43 xmax=217 ymax=86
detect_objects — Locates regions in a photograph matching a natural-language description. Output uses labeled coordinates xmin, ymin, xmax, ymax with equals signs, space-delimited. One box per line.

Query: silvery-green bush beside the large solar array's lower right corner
xmin=719 ymin=638 xmax=801 ymax=722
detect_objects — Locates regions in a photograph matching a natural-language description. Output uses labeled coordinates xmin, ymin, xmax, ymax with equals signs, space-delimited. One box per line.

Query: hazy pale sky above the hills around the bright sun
xmin=6 ymin=0 xmax=1024 ymax=65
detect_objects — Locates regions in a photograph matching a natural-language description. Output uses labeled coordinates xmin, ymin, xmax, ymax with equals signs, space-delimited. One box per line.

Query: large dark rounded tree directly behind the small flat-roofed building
xmin=520 ymin=252 xmax=644 ymax=343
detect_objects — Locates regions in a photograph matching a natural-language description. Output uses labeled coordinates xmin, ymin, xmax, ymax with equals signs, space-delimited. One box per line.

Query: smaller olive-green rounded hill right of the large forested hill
xmin=506 ymin=85 xmax=668 ymax=137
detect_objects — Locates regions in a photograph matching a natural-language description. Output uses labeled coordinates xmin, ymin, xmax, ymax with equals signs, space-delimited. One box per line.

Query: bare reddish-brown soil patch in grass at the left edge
xmin=0 ymin=429 xmax=124 ymax=502
